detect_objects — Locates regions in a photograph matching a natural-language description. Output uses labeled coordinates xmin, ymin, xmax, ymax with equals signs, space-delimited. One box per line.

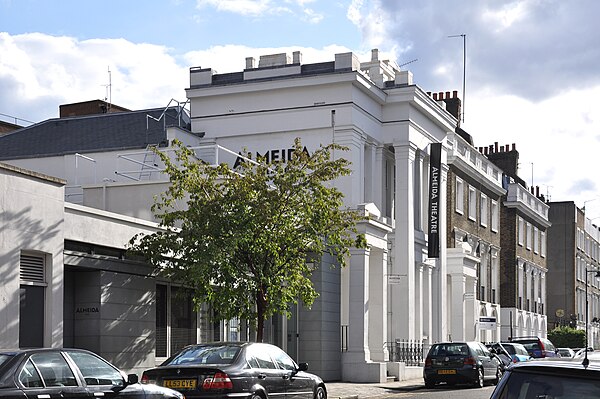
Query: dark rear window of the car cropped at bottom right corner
xmin=499 ymin=372 xmax=600 ymax=399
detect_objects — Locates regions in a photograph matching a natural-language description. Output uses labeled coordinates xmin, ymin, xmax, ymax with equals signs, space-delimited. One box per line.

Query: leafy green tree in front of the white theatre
xmin=130 ymin=139 xmax=366 ymax=342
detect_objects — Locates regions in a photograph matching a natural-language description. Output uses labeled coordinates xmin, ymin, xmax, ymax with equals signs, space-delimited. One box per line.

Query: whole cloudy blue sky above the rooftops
xmin=0 ymin=0 xmax=600 ymax=219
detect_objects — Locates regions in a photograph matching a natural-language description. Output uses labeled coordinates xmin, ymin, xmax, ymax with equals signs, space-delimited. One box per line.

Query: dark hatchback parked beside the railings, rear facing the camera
xmin=423 ymin=341 xmax=503 ymax=388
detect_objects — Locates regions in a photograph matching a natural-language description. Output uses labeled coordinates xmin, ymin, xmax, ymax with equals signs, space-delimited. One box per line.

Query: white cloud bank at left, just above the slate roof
xmin=0 ymin=33 xmax=189 ymax=121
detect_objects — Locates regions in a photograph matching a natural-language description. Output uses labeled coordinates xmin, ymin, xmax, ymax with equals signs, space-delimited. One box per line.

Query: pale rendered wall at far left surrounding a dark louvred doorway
xmin=0 ymin=164 xmax=64 ymax=348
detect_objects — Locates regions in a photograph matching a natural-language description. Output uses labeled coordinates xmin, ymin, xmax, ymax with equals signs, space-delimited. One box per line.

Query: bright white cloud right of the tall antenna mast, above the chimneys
xmin=463 ymin=86 xmax=600 ymax=209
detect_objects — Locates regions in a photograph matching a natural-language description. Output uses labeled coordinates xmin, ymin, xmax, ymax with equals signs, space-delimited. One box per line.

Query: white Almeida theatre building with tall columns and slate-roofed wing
xmin=0 ymin=50 xmax=464 ymax=382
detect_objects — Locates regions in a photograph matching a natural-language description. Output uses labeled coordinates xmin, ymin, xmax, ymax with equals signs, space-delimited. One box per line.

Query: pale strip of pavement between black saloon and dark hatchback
xmin=325 ymin=378 xmax=425 ymax=399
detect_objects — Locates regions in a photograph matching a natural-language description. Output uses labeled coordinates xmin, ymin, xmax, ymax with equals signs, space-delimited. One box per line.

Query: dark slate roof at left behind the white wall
xmin=0 ymin=107 xmax=189 ymax=160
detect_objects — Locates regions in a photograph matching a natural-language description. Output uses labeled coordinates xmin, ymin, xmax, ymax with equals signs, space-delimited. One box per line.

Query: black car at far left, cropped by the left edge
xmin=0 ymin=349 xmax=184 ymax=399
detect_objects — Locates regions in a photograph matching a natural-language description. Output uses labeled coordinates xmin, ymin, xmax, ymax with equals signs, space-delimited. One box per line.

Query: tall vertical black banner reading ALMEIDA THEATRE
xmin=427 ymin=143 xmax=442 ymax=258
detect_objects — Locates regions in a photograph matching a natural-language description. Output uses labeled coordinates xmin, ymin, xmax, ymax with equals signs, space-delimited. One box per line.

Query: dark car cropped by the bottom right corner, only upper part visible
xmin=491 ymin=358 xmax=600 ymax=399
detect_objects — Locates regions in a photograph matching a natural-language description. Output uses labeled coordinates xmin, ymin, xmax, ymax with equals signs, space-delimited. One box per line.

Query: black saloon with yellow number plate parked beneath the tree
xmin=141 ymin=342 xmax=327 ymax=399
